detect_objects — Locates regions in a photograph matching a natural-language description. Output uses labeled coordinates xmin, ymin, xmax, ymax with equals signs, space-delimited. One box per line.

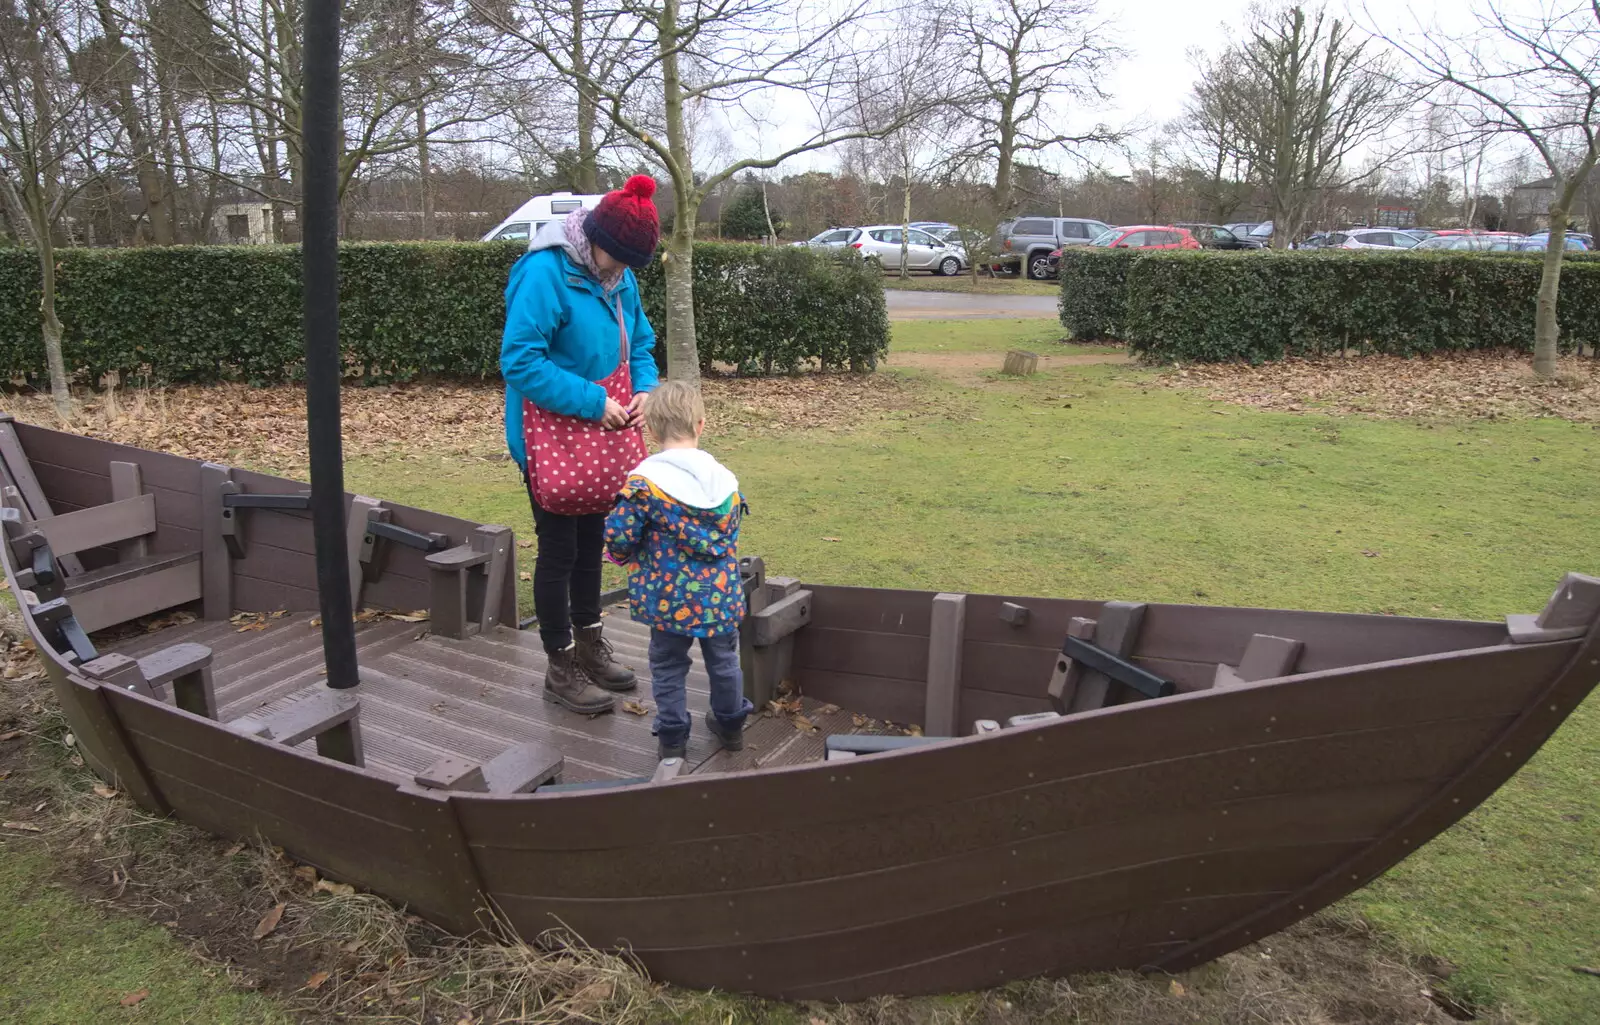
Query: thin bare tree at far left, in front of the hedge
xmin=0 ymin=0 xmax=116 ymax=422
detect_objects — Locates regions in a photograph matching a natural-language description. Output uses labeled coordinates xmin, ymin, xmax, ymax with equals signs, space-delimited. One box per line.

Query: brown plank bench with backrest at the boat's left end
xmin=0 ymin=450 xmax=202 ymax=633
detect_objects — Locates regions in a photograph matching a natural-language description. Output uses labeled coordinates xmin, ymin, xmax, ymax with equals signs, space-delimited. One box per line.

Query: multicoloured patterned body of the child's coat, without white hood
xmin=605 ymin=473 xmax=746 ymax=636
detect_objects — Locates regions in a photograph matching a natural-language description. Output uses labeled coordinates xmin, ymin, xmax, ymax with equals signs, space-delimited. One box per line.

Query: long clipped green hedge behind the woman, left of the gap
xmin=0 ymin=243 xmax=888 ymax=384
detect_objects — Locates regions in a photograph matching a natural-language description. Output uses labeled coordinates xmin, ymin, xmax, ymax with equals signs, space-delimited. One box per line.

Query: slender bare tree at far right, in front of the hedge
xmin=1386 ymin=0 xmax=1600 ymax=377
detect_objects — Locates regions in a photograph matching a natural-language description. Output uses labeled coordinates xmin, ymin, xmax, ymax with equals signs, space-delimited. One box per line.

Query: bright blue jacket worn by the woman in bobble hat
xmin=501 ymin=221 xmax=658 ymax=467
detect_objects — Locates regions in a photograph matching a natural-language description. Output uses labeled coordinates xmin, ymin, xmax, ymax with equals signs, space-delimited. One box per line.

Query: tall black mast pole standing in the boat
xmin=301 ymin=0 xmax=360 ymax=688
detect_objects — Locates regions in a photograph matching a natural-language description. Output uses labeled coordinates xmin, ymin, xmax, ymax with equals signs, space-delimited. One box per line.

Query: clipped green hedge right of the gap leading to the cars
xmin=1061 ymin=251 xmax=1600 ymax=363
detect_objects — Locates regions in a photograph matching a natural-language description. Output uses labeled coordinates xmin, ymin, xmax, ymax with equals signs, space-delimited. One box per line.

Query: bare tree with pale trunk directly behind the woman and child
xmin=472 ymin=0 xmax=921 ymax=381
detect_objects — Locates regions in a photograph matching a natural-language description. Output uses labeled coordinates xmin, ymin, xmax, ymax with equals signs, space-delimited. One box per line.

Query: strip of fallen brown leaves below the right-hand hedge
xmin=1162 ymin=352 xmax=1600 ymax=424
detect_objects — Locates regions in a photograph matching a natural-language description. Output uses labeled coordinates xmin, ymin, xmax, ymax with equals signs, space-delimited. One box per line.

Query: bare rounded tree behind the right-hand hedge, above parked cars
xmin=1195 ymin=5 xmax=1397 ymax=248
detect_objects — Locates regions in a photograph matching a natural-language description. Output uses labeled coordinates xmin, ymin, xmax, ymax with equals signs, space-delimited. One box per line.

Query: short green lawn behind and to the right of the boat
xmin=349 ymin=321 xmax=1600 ymax=1023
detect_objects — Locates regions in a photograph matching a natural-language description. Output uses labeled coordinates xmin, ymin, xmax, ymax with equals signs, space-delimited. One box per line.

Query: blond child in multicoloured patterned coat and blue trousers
xmin=605 ymin=381 xmax=752 ymax=758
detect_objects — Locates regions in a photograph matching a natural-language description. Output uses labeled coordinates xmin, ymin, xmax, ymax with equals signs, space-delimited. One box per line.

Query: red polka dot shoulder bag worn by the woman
xmin=522 ymin=304 xmax=650 ymax=516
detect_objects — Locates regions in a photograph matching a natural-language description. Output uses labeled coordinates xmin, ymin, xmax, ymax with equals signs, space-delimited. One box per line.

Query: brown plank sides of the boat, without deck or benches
xmin=6 ymin=425 xmax=1600 ymax=999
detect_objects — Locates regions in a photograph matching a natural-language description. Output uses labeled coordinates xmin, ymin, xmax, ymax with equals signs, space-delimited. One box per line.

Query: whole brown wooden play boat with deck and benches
xmin=0 ymin=412 xmax=1600 ymax=999
